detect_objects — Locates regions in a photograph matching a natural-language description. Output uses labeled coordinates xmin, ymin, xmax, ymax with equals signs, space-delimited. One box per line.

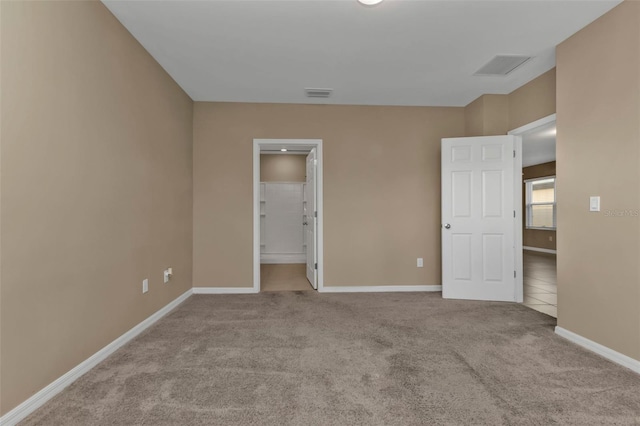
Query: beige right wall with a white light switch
xmin=557 ymin=1 xmax=640 ymax=360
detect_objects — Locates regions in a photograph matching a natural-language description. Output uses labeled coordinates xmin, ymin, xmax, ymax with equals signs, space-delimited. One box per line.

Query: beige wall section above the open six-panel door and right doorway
xmin=465 ymin=68 xmax=556 ymax=136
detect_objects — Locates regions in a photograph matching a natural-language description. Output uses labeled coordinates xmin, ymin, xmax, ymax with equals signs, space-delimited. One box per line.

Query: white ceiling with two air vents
xmin=103 ymin=0 xmax=621 ymax=106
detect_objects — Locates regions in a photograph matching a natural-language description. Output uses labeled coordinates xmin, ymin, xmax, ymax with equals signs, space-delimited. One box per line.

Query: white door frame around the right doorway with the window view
xmin=507 ymin=114 xmax=557 ymax=303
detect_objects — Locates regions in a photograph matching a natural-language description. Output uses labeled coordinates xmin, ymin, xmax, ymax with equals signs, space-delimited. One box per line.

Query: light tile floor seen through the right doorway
xmin=523 ymin=250 xmax=558 ymax=318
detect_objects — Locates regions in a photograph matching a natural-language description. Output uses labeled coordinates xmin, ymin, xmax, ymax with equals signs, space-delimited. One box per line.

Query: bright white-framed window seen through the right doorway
xmin=525 ymin=176 xmax=556 ymax=229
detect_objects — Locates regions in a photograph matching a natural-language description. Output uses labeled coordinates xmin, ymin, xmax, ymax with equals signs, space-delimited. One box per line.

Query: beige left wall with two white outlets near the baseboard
xmin=0 ymin=1 xmax=193 ymax=414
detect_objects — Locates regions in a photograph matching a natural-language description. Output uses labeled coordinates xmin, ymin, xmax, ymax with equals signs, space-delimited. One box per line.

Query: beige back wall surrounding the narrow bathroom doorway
xmin=193 ymin=102 xmax=464 ymax=287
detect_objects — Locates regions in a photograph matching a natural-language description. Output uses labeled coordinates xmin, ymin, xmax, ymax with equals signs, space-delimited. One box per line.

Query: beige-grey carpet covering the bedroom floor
xmin=18 ymin=292 xmax=640 ymax=426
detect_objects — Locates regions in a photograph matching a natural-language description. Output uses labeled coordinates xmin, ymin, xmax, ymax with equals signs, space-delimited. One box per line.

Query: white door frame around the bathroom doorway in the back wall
xmin=253 ymin=139 xmax=324 ymax=293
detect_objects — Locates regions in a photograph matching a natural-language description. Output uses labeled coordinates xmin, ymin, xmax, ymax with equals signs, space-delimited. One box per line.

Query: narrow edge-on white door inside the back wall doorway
xmin=304 ymin=148 xmax=318 ymax=290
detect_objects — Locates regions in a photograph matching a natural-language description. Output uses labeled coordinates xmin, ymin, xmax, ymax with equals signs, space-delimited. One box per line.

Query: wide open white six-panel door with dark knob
xmin=442 ymin=136 xmax=517 ymax=302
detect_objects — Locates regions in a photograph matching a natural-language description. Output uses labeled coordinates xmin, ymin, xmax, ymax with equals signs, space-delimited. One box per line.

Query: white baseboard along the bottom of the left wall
xmin=0 ymin=289 xmax=191 ymax=426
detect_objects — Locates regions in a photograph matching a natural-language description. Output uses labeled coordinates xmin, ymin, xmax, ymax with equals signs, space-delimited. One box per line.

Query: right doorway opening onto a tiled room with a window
xmin=509 ymin=114 xmax=558 ymax=318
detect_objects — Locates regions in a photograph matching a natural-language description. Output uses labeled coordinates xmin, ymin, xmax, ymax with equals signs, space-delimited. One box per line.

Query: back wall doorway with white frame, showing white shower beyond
xmin=253 ymin=139 xmax=323 ymax=292
